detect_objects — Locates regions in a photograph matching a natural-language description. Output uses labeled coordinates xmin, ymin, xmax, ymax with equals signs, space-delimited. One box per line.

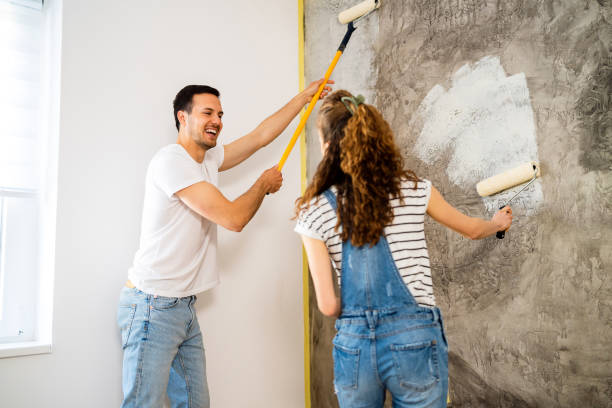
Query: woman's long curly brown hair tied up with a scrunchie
xmin=295 ymin=90 xmax=419 ymax=247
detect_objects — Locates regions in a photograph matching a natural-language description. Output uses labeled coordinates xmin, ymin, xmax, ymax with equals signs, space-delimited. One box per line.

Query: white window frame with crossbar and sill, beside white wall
xmin=0 ymin=0 xmax=62 ymax=358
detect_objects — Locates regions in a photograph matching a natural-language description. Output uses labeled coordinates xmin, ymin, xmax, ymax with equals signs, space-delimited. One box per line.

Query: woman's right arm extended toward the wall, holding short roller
xmin=427 ymin=185 xmax=512 ymax=239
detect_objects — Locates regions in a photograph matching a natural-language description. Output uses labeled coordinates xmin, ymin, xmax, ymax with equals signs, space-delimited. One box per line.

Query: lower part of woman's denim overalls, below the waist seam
xmin=333 ymin=308 xmax=448 ymax=408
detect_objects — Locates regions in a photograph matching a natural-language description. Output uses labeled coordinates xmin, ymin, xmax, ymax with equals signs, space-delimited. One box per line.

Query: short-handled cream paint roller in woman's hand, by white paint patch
xmin=476 ymin=161 xmax=540 ymax=239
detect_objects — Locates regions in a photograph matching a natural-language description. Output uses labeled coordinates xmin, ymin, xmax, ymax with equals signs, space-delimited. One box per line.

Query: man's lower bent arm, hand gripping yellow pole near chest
xmin=175 ymin=166 xmax=283 ymax=232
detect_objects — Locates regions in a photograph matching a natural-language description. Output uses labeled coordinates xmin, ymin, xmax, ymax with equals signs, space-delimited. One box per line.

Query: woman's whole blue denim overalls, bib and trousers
xmin=324 ymin=190 xmax=448 ymax=408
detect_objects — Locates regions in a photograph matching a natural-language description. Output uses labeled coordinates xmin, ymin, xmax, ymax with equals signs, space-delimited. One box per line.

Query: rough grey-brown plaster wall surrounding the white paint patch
xmin=305 ymin=0 xmax=612 ymax=407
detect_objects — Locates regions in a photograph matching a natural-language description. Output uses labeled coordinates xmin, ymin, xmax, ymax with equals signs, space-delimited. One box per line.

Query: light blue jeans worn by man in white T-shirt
xmin=117 ymin=287 xmax=210 ymax=408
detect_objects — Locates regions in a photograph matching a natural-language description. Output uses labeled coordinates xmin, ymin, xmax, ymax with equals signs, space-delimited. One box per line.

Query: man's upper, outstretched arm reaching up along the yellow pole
xmin=219 ymin=79 xmax=334 ymax=171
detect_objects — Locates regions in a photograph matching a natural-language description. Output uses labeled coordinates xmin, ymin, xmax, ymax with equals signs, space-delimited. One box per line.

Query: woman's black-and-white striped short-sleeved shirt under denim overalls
xmin=295 ymin=180 xmax=436 ymax=307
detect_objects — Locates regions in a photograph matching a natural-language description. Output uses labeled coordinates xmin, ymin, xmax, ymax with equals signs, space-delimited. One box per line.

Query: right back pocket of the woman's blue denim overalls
xmin=391 ymin=340 xmax=440 ymax=392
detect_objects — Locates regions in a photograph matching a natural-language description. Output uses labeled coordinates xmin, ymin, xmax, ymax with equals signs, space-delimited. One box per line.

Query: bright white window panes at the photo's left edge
xmin=0 ymin=0 xmax=43 ymax=343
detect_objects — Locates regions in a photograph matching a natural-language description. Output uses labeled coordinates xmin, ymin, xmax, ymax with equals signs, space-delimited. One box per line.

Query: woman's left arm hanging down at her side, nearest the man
xmin=302 ymin=235 xmax=340 ymax=317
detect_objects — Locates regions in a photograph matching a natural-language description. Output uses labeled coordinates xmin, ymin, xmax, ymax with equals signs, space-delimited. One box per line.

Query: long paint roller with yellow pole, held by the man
xmin=278 ymin=0 xmax=380 ymax=171
